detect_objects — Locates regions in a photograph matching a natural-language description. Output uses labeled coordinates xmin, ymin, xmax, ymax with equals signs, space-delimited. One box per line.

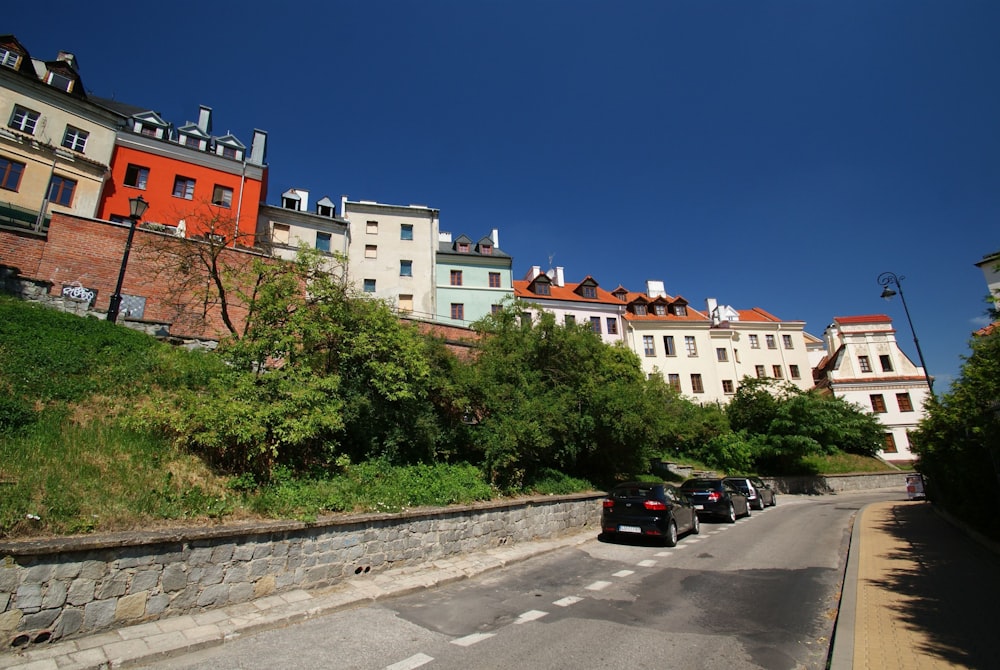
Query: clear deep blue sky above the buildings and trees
xmin=4 ymin=0 xmax=1000 ymax=390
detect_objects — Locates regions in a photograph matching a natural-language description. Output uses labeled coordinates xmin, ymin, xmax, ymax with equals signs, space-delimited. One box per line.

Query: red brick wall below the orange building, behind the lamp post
xmin=0 ymin=213 xmax=254 ymax=339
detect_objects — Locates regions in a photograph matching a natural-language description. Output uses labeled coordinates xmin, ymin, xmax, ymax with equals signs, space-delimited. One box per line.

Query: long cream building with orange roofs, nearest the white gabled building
xmin=612 ymin=281 xmax=815 ymax=403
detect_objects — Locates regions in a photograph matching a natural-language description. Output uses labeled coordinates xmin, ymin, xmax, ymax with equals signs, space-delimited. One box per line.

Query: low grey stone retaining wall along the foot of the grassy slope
xmin=0 ymin=494 xmax=601 ymax=650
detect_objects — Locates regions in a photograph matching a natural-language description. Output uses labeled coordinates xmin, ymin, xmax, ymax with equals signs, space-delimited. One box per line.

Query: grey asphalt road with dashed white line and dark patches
xmin=143 ymin=492 xmax=898 ymax=670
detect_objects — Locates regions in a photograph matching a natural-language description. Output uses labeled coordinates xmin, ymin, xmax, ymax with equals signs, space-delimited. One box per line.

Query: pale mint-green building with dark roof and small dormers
xmin=435 ymin=228 xmax=514 ymax=326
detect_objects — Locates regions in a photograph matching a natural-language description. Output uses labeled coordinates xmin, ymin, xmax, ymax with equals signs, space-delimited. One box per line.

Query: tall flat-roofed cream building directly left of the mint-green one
xmin=340 ymin=196 xmax=440 ymax=320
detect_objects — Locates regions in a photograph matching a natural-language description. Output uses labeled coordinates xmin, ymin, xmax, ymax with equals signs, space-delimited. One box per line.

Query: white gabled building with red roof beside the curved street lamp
xmin=816 ymin=314 xmax=930 ymax=464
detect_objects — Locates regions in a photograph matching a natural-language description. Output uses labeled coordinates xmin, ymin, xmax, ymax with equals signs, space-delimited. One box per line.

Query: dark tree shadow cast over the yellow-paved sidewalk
xmin=873 ymin=502 xmax=1000 ymax=668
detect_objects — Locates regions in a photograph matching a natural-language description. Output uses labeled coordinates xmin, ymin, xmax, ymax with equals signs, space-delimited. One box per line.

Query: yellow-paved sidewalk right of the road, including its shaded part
xmin=830 ymin=501 xmax=1000 ymax=670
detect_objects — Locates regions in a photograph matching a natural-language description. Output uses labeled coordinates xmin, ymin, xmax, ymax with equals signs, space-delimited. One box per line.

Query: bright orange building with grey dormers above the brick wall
xmin=97 ymin=100 xmax=267 ymax=247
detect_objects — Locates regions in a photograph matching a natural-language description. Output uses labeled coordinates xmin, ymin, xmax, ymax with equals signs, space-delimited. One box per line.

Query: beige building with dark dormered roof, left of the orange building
xmin=0 ymin=35 xmax=120 ymax=229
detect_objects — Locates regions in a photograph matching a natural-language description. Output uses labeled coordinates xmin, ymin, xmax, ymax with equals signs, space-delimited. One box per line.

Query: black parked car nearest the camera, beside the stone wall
xmin=601 ymin=482 xmax=700 ymax=547
